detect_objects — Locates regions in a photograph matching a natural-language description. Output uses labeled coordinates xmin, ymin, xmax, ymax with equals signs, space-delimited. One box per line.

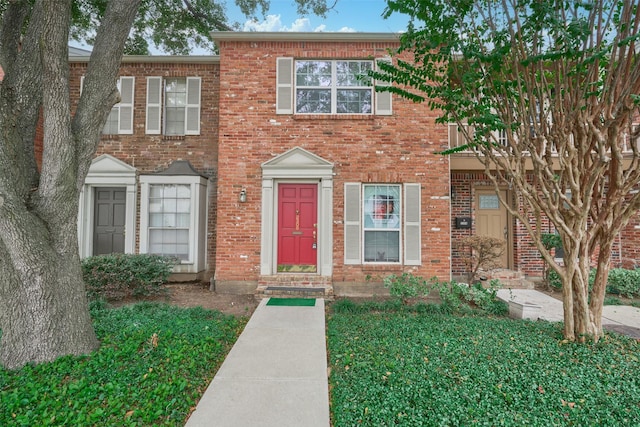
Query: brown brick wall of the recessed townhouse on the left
xmin=70 ymin=57 xmax=220 ymax=274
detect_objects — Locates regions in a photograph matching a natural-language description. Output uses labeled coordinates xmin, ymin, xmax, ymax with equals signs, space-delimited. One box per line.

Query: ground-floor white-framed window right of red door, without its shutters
xmin=362 ymin=184 xmax=401 ymax=263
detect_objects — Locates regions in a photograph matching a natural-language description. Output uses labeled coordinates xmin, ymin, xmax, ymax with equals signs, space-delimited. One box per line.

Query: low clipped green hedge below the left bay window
xmin=82 ymin=254 xmax=175 ymax=300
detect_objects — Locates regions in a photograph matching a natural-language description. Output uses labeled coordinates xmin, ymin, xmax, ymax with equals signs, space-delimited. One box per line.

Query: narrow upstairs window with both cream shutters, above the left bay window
xmin=146 ymin=77 xmax=201 ymax=135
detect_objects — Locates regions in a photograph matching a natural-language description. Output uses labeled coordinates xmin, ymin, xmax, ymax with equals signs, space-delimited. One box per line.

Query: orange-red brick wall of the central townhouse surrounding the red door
xmin=215 ymin=38 xmax=450 ymax=288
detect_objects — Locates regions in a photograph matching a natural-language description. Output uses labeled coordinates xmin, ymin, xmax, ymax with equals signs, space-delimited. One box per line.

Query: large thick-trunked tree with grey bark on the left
xmin=0 ymin=0 xmax=338 ymax=368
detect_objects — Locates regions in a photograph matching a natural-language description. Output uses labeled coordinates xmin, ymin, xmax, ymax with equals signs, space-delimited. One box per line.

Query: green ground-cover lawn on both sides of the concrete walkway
xmin=0 ymin=303 xmax=640 ymax=427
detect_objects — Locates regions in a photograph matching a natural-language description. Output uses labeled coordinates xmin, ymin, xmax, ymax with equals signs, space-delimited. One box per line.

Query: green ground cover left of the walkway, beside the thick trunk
xmin=0 ymin=303 xmax=246 ymax=426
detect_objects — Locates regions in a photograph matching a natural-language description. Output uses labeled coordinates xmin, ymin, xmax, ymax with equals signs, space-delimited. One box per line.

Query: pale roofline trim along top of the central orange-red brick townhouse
xmin=209 ymin=31 xmax=401 ymax=43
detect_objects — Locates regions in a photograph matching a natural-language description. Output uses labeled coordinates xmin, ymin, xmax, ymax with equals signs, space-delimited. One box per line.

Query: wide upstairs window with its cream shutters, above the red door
xmin=276 ymin=58 xmax=392 ymax=115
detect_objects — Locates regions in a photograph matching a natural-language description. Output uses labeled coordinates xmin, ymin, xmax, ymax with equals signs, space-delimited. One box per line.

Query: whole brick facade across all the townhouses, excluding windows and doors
xmin=52 ymin=33 xmax=640 ymax=293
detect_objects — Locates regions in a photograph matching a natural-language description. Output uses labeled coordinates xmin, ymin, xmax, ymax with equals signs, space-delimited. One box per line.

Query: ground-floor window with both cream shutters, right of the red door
xmin=344 ymin=183 xmax=422 ymax=265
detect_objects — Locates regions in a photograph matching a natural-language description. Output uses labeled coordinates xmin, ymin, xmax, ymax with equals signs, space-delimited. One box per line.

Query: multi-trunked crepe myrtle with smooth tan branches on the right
xmin=375 ymin=0 xmax=640 ymax=342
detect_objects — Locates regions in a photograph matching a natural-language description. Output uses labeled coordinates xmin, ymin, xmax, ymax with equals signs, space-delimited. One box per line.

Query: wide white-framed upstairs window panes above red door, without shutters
xmin=295 ymin=60 xmax=373 ymax=114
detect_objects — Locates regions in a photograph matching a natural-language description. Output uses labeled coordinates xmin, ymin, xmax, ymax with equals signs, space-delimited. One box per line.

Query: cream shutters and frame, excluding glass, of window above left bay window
xmin=145 ymin=76 xmax=202 ymax=136
